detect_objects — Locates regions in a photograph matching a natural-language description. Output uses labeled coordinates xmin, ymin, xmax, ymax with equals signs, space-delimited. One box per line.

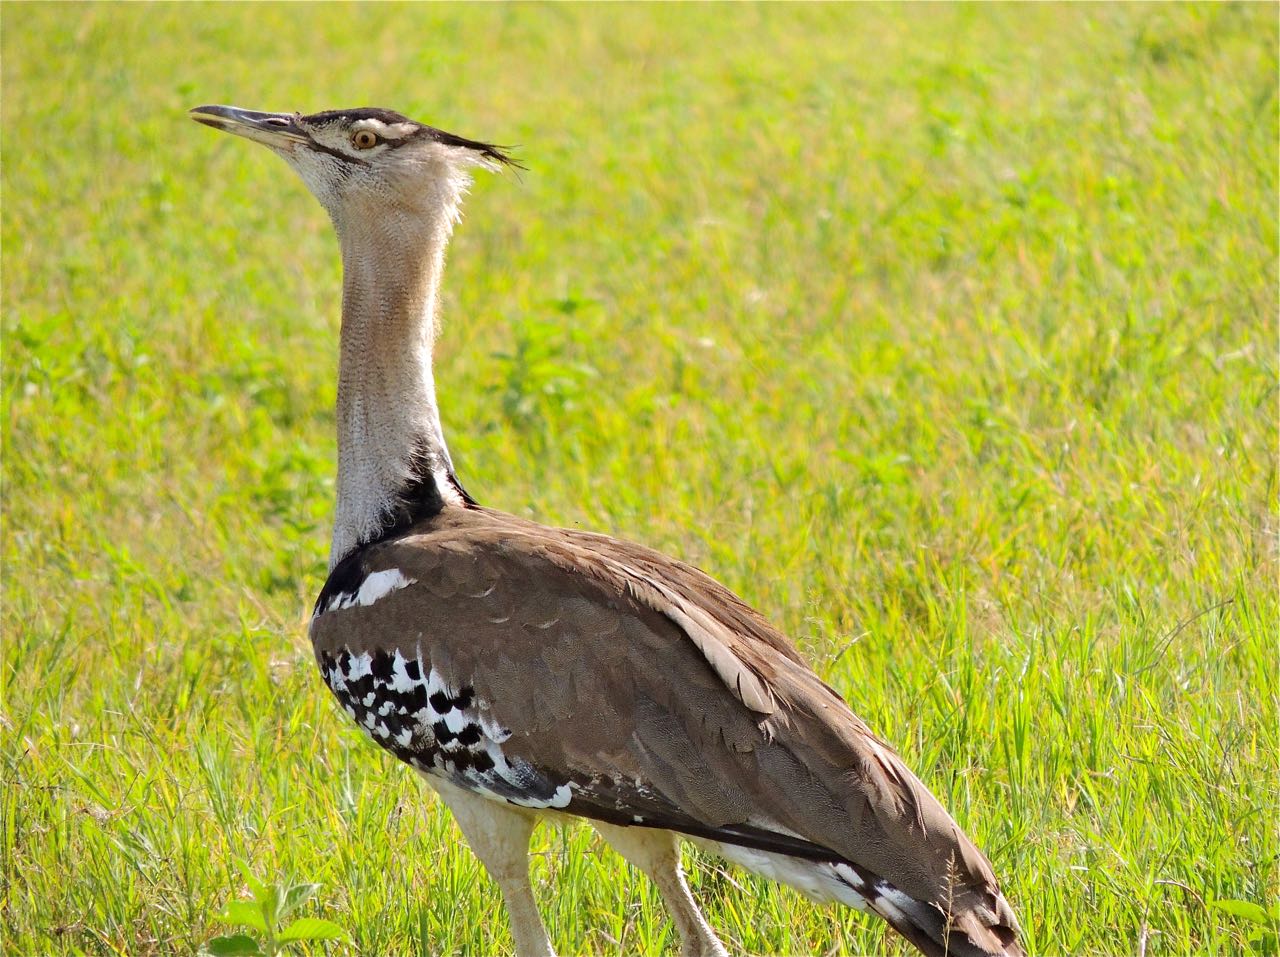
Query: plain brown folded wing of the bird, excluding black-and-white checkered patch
xmin=314 ymin=509 xmax=1007 ymax=951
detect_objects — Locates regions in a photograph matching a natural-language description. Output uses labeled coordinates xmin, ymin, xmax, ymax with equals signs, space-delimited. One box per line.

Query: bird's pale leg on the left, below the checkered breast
xmin=431 ymin=780 xmax=556 ymax=957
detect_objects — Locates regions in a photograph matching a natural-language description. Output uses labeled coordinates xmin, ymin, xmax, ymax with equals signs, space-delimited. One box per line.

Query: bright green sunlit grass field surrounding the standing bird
xmin=0 ymin=4 xmax=1280 ymax=954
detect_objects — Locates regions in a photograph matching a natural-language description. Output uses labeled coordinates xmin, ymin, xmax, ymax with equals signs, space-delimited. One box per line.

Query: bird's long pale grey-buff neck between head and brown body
xmin=329 ymin=205 xmax=465 ymax=569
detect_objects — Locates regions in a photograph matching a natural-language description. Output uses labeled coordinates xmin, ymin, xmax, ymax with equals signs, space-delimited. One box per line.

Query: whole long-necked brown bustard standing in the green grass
xmin=189 ymin=105 xmax=1024 ymax=957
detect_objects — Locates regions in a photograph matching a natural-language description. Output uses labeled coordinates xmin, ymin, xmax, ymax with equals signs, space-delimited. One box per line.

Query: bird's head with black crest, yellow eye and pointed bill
xmin=191 ymin=106 xmax=517 ymax=232
